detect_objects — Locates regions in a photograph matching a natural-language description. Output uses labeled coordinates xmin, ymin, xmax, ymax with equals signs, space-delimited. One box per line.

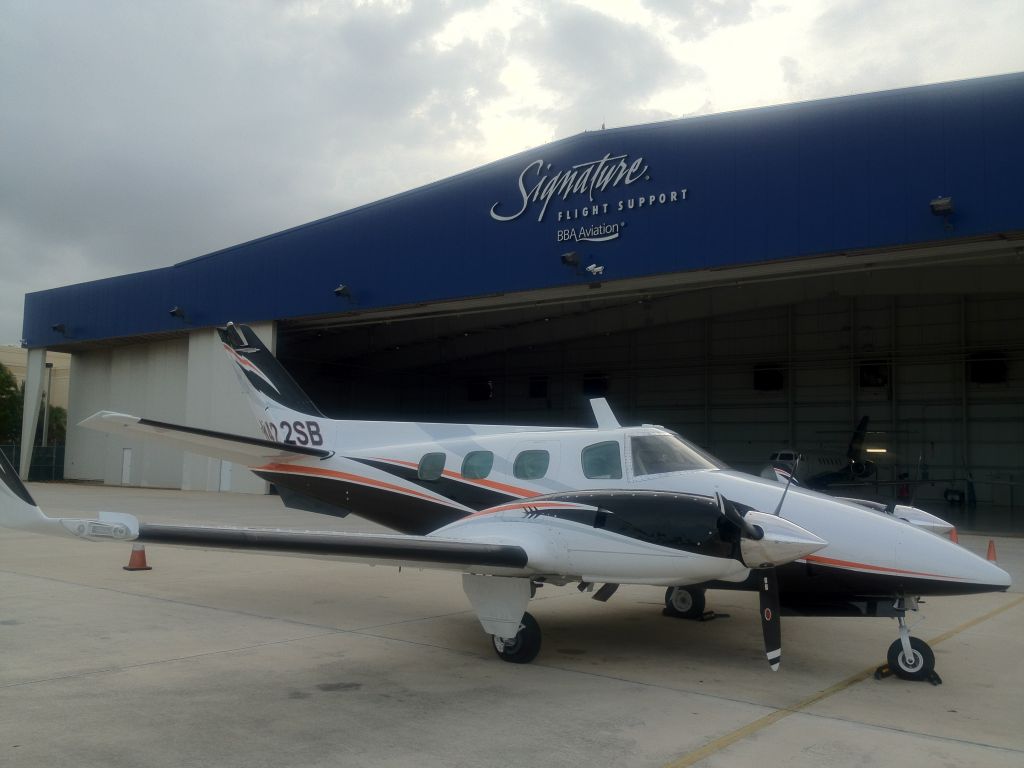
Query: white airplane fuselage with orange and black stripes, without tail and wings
xmin=253 ymin=420 xmax=1010 ymax=600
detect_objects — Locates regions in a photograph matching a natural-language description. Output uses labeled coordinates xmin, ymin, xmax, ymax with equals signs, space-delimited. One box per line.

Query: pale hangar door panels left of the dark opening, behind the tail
xmin=65 ymin=323 xmax=275 ymax=494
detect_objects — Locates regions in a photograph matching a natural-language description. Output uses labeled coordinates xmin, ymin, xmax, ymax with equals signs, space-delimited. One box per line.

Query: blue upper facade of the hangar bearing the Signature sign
xmin=24 ymin=74 xmax=1024 ymax=346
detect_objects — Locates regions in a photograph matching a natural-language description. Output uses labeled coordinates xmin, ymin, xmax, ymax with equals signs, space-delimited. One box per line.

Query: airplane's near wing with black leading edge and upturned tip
xmin=0 ymin=453 xmax=528 ymax=575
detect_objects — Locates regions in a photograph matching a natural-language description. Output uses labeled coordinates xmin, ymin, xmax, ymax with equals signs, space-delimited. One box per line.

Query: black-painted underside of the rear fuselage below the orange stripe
xmin=254 ymin=470 xmax=469 ymax=536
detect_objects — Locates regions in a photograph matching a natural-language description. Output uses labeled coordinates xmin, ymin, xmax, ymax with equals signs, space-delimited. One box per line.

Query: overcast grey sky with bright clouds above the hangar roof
xmin=0 ymin=0 xmax=1024 ymax=343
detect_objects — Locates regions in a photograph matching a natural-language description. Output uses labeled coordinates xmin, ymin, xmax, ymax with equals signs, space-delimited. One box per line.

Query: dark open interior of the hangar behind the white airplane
xmin=279 ymin=256 xmax=1024 ymax=529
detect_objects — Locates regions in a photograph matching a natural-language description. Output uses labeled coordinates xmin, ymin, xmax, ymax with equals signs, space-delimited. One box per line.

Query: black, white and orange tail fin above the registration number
xmin=217 ymin=323 xmax=325 ymax=421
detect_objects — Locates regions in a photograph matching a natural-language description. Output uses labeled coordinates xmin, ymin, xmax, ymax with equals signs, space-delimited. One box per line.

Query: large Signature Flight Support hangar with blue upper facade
xmin=14 ymin=74 xmax=1024 ymax=529
